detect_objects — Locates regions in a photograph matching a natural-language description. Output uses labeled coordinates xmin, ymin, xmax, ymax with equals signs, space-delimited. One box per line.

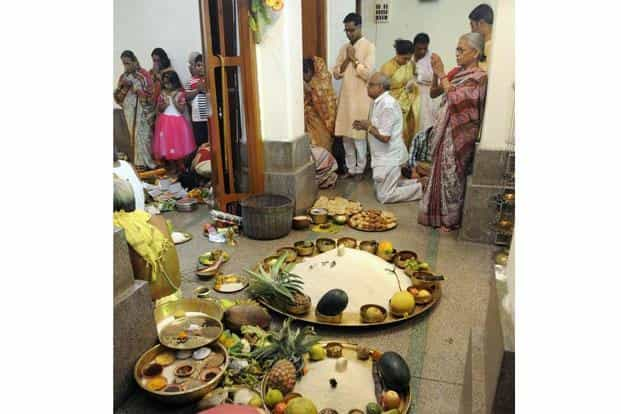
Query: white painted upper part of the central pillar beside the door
xmin=256 ymin=0 xmax=304 ymax=141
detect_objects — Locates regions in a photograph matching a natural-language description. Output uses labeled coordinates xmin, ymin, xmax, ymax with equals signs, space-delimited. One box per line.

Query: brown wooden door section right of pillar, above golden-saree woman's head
xmin=302 ymin=0 xmax=327 ymax=60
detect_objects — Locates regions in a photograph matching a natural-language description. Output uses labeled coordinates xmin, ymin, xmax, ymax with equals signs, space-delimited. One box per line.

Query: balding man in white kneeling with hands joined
xmin=353 ymin=72 xmax=423 ymax=204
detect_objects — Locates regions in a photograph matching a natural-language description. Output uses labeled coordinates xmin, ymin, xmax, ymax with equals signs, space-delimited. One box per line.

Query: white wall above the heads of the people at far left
xmin=113 ymin=0 xmax=202 ymax=86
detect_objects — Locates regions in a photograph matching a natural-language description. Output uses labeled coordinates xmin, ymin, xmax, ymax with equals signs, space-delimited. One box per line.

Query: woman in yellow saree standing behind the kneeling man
xmin=380 ymin=39 xmax=420 ymax=149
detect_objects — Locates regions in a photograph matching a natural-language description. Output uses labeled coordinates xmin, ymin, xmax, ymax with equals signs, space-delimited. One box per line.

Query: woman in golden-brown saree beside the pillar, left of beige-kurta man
xmin=302 ymin=56 xmax=338 ymax=188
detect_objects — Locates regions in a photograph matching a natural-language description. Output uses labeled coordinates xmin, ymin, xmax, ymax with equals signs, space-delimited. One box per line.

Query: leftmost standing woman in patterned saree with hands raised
xmin=114 ymin=50 xmax=156 ymax=169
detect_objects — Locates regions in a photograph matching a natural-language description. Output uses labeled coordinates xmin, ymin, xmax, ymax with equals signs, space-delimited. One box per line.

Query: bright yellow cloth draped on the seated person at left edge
xmin=114 ymin=210 xmax=178 ymax=290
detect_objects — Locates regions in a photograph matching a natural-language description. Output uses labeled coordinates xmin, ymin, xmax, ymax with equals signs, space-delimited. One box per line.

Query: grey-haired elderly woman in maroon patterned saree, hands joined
xmin=418 ymin=33 xmax=487 ymax=231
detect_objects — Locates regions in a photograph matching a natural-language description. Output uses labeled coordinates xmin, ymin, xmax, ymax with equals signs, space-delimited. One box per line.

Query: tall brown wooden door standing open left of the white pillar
xmin=200 ymin=0 xmax=264 ymax=214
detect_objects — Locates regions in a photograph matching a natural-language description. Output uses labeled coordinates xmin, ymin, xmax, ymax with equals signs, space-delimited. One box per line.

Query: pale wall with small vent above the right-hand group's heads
xmin=361 ymin=0 xmax=499 ymax=76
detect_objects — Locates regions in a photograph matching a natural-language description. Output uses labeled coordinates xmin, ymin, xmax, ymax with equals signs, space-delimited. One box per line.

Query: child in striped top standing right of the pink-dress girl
xmin=185 ymin=52 xmax=211 ymax=145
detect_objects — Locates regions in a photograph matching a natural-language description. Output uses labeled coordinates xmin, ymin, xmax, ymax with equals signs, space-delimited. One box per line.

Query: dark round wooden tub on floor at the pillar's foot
xmin=241 ymin=194 xmax=293 ymax=240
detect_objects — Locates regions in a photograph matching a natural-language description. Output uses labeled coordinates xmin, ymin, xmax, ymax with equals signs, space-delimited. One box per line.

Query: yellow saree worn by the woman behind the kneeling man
xmin=380 ymin=58 xmax=420 ymax=149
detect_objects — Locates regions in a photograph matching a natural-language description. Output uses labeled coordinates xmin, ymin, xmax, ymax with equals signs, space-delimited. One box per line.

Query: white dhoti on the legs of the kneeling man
xmin=373 ymin=165 xmax=423 ymax=204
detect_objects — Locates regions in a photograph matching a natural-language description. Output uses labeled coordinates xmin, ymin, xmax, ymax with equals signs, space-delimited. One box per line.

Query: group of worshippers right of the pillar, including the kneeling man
xmin=303 ymin=4 xmax=493 ymax=231
